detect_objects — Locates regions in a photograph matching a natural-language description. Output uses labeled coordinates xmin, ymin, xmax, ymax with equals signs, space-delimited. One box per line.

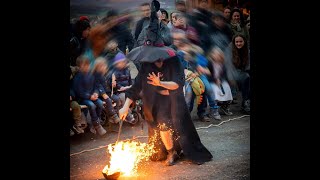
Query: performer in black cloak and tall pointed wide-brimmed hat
xmin=119 ymin=0 xmax=212 ymax=166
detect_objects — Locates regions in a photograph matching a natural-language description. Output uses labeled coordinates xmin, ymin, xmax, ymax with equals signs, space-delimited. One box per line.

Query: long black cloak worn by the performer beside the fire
xmin=126 ymin=56 xmax=212 ymax=164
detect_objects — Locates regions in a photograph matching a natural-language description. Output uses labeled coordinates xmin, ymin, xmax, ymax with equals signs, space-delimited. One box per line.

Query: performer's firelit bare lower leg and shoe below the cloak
xmin=160 ymin=131 xmax=179 ymax=166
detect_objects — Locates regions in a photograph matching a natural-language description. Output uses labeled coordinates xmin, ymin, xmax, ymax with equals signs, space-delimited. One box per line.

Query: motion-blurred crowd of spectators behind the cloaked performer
xmin=69 ymin=0 xmax=250 ymax=136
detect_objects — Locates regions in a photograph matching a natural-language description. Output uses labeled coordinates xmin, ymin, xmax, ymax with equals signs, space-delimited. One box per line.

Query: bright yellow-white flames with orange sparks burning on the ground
xmin=102 ymin=141 xmax=155 ymax=176
